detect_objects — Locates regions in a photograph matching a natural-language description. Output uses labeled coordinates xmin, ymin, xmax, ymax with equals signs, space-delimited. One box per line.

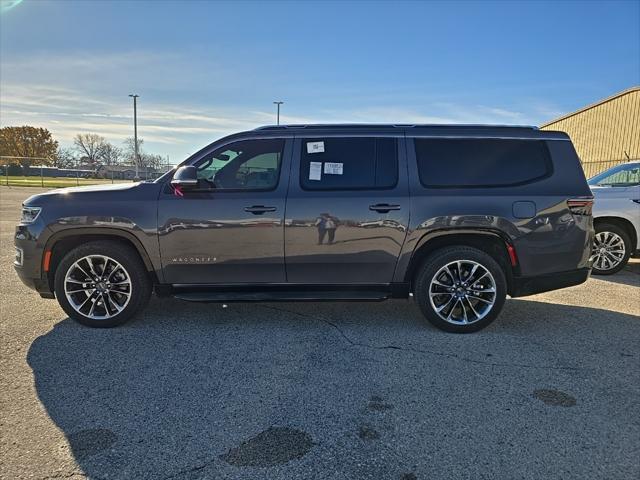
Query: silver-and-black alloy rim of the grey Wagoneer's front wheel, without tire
xmin=64 ymin=255 xmax=132 ymax=320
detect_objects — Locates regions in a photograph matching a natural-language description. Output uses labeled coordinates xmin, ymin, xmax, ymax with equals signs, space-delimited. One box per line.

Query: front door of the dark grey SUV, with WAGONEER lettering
xmin=158 ymin=137 xmax=292 ymax=284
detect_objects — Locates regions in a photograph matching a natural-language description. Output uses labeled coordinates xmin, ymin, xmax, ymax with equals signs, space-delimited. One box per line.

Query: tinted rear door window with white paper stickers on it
xmin=300 ymin=137 xmax=398 ymax=190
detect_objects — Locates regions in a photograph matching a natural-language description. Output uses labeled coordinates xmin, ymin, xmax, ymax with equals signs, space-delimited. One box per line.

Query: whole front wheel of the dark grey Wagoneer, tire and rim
xmin=55 ymin=241 xmax=151 ymax=327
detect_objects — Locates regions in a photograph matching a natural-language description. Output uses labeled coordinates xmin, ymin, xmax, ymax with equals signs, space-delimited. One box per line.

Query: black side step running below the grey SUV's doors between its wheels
xmin=173 ymin=290 xmax=391 ymax=303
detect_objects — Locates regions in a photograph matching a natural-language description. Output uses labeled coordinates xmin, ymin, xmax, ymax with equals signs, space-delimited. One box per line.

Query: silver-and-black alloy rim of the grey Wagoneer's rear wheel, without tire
xmin=429 ymin=260 xmax=496 ymax=325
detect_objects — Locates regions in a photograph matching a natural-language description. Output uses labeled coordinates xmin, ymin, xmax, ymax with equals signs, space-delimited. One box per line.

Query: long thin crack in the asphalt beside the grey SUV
xmin=261 ymin=305 xmax=588 ymax=371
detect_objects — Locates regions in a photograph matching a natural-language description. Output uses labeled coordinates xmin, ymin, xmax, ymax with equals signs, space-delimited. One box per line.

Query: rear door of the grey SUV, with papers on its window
xmin=285 ymin=131 xmax=409 ymax=284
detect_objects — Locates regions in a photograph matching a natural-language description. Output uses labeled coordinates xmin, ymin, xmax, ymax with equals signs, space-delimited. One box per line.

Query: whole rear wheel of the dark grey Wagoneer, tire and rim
xmin=414 ymin=246 xmax=507 ymax=333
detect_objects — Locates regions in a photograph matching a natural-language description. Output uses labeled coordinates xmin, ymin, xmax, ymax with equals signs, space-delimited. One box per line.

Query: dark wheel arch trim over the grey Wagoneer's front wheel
xmin=43 ymin=228 xmax=159 ymax=291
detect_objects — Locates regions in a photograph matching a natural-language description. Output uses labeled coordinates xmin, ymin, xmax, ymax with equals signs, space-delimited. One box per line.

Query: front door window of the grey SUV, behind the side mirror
xmin=196 ymin=139 xmax=284 ymax=190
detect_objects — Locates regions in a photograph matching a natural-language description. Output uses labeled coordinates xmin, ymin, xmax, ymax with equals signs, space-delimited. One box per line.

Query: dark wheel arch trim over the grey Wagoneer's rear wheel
xmin=405 ymin=229 xmax=517 ymax=293
